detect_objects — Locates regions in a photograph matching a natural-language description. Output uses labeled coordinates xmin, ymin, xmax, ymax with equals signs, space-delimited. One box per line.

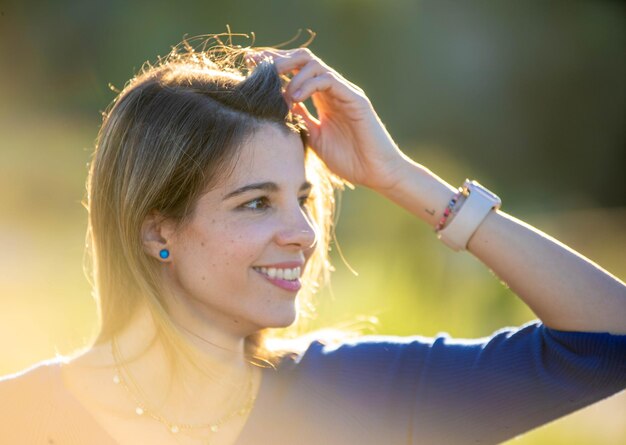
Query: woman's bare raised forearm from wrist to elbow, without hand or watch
xmin=382 ymin=162 xmax=626 ymax=334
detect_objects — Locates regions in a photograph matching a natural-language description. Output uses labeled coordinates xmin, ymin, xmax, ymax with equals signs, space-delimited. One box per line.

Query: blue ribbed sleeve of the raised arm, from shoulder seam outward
xmin=412 ymin=322 xmax=626 ymax=444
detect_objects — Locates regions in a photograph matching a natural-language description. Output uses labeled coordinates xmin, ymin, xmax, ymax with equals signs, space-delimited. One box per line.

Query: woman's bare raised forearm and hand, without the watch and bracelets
xmin=261 ymin=49 xmax=626 ymax=334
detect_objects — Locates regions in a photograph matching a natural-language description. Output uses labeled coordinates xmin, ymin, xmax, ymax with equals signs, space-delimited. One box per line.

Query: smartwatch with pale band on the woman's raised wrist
xmin=437 ymin=179 xmax=502 ymax=252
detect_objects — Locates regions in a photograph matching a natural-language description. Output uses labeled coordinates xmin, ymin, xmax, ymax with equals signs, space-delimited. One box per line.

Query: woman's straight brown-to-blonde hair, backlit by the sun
xmin=86 ymin=38 xmax=376 ymax=372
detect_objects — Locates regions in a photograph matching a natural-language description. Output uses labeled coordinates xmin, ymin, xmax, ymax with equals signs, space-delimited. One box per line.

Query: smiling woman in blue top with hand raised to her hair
xmin=0 ymin=38 xmax=626 ymax=445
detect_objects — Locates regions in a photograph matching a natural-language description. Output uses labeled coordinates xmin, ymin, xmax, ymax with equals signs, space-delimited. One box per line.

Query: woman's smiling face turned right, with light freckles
xmin=164 ymin=124 xmax=316 ymax=333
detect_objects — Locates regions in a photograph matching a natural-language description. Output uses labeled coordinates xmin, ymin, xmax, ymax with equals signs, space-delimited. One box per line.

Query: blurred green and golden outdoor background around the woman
xmin=0 ymin=0 xmax=626 ymax=445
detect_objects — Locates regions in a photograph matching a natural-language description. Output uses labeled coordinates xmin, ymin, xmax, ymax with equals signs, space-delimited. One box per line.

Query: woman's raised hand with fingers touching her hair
xmin=250 ymin=48 xmax=408 ymax=192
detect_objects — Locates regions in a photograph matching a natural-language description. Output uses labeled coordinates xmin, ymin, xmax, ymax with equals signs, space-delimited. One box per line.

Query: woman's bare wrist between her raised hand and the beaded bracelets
xmin=377 ymin=158 xmax=460 ymax=227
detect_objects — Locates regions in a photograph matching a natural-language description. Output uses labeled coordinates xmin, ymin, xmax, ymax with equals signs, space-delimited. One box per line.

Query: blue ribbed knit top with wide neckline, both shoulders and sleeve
xmin=0 ymin=321 xmax=626 ymax=445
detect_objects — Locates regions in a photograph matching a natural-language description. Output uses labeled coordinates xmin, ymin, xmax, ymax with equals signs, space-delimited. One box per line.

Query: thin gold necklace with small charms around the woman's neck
xmin=111 ymin=338 xmax=256 ymax=434
